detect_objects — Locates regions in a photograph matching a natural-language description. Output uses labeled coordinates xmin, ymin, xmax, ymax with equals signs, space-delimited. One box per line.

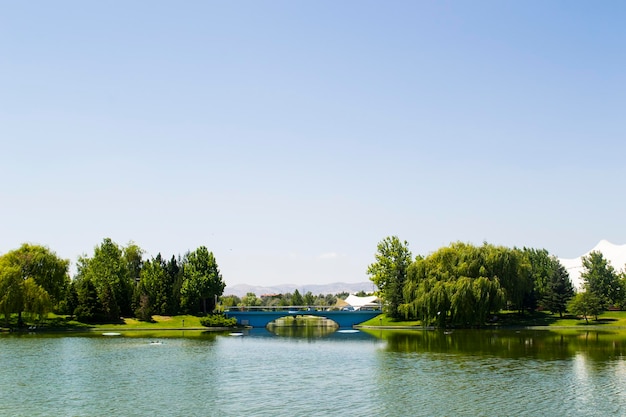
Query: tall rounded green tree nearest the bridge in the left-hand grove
xmin=181 ymin=246 xmax=226 ymax=314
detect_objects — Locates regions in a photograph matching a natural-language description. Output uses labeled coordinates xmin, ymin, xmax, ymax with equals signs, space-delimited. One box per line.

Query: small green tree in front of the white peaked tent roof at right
xmin=580 ymin=251 xmax=623 ymax=306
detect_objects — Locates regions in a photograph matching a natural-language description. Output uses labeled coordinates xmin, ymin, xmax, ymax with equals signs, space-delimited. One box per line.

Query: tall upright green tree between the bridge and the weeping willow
xmin=367 ymin=236 xmax=412 ymax=318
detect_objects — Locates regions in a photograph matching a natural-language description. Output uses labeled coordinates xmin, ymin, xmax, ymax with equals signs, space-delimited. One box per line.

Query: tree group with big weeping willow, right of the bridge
xmin=367 ymin=236 xmax=626 ymax=327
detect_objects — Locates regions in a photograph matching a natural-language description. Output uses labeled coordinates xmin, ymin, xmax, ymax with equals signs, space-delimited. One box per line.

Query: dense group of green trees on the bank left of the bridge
xmin=0 ymin=238 xmax=226 ymax=324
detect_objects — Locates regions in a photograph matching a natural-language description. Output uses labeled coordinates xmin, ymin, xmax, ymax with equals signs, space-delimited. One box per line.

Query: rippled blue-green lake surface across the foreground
xmin=0 ymin=329 xmax=626 ymax=416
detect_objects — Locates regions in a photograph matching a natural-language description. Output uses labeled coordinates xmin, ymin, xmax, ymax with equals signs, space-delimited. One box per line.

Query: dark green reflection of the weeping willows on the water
xmin=370 ymin=330 xmax=626 ymax=360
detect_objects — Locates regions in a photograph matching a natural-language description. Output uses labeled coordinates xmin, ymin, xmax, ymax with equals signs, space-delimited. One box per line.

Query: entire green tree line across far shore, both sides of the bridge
xmin=0 ymin=236 xmax=626 ymax=327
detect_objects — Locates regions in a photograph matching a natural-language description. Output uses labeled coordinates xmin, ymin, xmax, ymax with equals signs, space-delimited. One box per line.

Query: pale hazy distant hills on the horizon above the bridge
xmin=224 ymin=281 xmax=375 ymax=297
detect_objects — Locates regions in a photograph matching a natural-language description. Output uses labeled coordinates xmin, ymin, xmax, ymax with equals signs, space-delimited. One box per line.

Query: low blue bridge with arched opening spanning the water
xmin=224 ymin=306 xmax=381 ymax=327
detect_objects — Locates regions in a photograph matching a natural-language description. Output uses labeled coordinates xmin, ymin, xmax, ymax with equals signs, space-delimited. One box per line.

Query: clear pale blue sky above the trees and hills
xmin=0 ymin=0 xmax=626 ymax=285
